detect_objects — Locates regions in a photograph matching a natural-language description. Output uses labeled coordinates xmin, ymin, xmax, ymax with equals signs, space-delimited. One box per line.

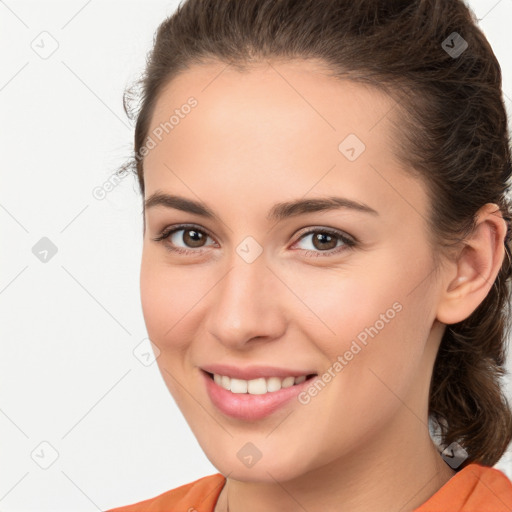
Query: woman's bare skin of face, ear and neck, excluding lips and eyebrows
xmin=140 ymin=61 xmax=506 ymax=512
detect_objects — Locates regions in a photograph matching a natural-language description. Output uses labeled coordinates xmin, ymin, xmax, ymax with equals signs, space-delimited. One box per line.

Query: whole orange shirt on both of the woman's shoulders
xmin=107 ymin=464 xmax=512 ymax=512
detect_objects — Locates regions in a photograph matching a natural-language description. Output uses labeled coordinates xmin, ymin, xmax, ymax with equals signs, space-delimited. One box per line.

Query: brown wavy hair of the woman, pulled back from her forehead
xmin=122 ymin=0 xmax=512 ymax=469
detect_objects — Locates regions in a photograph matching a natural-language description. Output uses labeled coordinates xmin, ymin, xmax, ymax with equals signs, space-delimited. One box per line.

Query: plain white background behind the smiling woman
xmin=0 ymin=0 xmax=512 ymax=512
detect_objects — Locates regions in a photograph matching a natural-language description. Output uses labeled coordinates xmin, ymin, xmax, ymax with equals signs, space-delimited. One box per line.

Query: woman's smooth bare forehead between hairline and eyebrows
xmin=144 ymin=61 xmax=427 ymax=224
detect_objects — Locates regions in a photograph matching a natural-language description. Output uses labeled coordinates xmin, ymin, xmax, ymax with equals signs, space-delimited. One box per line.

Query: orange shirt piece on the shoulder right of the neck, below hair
xmin=414 ymin=463 xmax=512 ymax=512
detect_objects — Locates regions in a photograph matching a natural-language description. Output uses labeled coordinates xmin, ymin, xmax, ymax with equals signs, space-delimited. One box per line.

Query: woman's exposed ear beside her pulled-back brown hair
xmin=437 ymin=203 xmax=507 ymax=324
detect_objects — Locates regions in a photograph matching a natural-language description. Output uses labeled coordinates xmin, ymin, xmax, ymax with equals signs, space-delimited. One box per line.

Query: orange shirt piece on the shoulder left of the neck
xmin=106 ymin=473 xmax=226 ymax=512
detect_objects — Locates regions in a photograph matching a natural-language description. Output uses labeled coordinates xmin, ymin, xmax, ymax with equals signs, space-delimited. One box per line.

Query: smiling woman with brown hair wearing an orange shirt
xmin=105 ymin=0 xmax=512 ymax=512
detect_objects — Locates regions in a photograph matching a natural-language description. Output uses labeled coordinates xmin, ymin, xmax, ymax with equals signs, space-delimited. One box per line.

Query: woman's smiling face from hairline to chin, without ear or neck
xmin=141 ymin=61 xmax=448 ymax=481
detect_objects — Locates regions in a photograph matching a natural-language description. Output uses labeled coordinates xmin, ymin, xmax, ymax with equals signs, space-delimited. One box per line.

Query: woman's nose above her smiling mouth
xmin=206 ymin=254 xmax=287 ymax=350
